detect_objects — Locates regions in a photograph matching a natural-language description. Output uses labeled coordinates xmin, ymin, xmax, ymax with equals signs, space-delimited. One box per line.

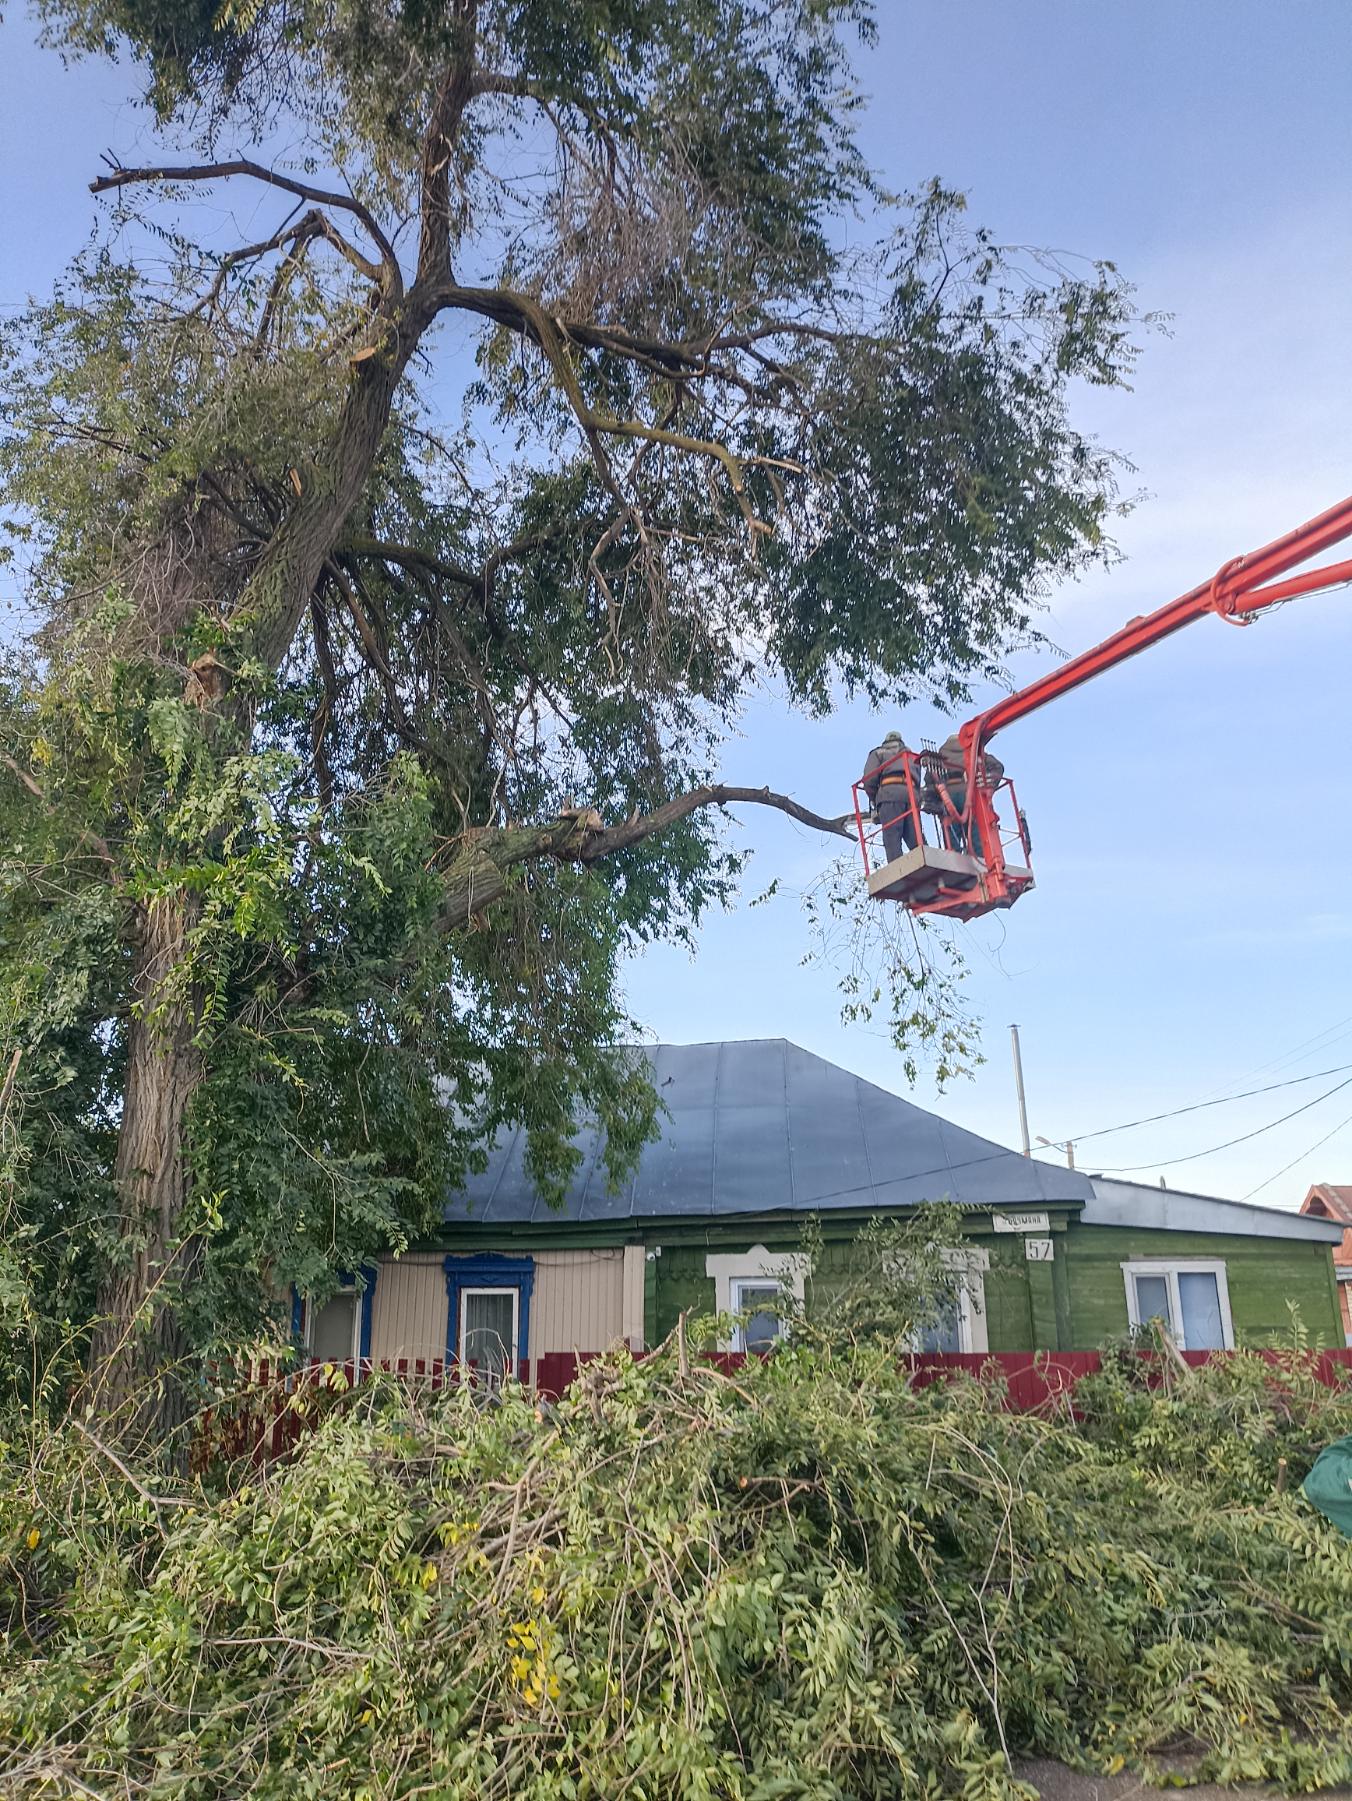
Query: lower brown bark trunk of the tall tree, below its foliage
xmin=90 ymin=895 xmax=202 ymax=1444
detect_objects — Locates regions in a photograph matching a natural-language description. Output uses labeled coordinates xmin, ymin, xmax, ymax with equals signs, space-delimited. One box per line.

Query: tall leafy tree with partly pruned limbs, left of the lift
xmin=0 ymin=0 xmax=1131 ymax=1423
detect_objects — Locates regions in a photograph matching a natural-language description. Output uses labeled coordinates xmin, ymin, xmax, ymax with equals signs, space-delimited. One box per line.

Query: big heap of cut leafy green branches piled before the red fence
xmin=0 ymin=1344 xmax=1352 ymax=1801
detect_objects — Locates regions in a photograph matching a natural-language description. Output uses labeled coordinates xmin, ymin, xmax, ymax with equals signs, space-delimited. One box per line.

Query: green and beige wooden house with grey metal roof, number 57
xmin=302 ymin=1039 xmax=1343 ymax=1363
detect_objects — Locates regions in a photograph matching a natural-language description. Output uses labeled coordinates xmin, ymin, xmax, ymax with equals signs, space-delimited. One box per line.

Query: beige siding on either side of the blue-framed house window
xmin=371 ymin=1244 xmax=643 ymax=1363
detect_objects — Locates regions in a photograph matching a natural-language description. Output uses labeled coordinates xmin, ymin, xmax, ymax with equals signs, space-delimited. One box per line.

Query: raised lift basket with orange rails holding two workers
xmin=853 ymin=749 xmax=1033 ymax=920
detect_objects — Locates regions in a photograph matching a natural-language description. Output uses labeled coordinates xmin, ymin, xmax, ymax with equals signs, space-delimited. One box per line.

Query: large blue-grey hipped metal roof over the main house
xmin=446 ymin=1037 xmax=1093 ymax=1225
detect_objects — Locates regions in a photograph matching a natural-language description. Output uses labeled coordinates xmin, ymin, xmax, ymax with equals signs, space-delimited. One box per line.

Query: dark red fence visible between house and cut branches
xmin=198 ymin=1349 xmax=1352 ymax=1462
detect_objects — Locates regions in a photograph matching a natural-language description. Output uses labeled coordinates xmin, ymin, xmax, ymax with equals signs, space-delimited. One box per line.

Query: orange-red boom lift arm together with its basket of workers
xmin=855 ymin=495 xmax=1352 ymax=919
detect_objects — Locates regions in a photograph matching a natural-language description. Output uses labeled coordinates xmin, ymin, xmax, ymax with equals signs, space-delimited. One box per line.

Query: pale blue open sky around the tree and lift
xmin=0 ymin=0 xmax=1352 ymax=1207
